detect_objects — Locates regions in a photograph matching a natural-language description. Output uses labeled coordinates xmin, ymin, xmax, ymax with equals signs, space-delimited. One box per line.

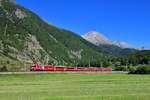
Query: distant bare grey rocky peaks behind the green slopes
xmin=82 ymin=31 xmax=133 ymax=48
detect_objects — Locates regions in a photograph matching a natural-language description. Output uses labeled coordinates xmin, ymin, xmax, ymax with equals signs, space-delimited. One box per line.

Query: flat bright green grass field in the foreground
xmin=0 ymin=73 xmax=150 ymax=100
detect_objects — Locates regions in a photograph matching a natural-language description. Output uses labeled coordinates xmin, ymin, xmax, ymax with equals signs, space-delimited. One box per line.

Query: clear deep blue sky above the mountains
xmin=17 ymin=0 xmax=150 ymax=48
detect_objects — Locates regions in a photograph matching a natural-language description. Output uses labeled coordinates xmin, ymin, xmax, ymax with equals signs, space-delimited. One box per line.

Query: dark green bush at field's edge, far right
xmin=129 ymin=66 xmax=150 ymax=74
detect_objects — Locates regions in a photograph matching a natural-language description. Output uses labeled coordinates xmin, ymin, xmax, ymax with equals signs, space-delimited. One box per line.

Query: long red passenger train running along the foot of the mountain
xmin=30 ymin=65 xmax=112 ymax=72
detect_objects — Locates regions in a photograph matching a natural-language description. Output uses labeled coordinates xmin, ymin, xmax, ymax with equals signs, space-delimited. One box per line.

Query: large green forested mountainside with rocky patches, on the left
xmin=0 ymin=0 xmax=112 ymax=71
